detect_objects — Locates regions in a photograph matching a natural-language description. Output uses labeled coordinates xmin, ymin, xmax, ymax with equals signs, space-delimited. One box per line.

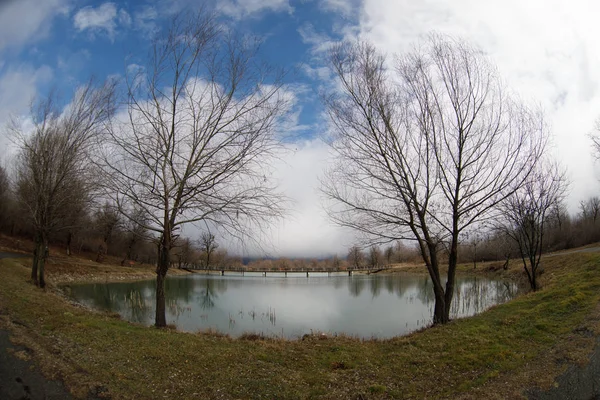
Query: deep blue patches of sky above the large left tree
xmin=0 ymin=0 xmax=348 ymax=137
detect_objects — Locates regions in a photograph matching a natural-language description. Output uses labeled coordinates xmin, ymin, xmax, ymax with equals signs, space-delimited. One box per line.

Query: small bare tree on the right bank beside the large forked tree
xmin=501 ymin=164 xmax=567 ymax=291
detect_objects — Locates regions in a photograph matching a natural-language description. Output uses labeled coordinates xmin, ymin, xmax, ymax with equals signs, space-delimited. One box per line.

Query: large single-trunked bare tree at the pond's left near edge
xmin=104 ymin=11 xmax=288 ymax=327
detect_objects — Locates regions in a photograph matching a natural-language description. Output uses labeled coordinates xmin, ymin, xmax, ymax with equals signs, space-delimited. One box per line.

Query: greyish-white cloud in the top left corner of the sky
xmin=0 ymin=0 xmax=70 ymax=51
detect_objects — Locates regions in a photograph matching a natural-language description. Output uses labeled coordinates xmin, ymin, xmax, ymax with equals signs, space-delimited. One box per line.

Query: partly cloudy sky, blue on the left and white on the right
xmin=0 ymin=0 xmax=600 ymax=257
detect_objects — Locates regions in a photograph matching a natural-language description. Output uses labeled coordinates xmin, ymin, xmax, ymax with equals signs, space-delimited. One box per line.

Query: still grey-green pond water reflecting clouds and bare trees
xmin=64 ymin=274 xmax=516 ymax=339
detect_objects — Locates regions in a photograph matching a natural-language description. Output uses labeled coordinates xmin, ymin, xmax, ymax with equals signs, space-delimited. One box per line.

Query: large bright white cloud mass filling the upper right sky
xmin=318 ymin=0 xmax=600 ymax=211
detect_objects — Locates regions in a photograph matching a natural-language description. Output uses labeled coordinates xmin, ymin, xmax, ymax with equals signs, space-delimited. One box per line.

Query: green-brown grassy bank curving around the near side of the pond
xmin=0 ymin=254 xmax=600 ymax=399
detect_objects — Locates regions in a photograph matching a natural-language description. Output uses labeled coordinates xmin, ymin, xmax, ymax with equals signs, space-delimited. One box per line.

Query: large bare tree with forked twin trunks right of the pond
xmin=323 ymin=35 xmax=547 ymax=323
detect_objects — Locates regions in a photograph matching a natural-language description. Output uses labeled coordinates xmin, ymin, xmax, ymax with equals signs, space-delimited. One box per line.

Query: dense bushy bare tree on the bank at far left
xmin=9 ymin=81 xmax=115 ymax=287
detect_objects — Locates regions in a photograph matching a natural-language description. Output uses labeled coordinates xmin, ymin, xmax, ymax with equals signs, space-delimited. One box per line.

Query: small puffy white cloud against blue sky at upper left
xmin=73 ymin=3 xmax=131 ymax=40
